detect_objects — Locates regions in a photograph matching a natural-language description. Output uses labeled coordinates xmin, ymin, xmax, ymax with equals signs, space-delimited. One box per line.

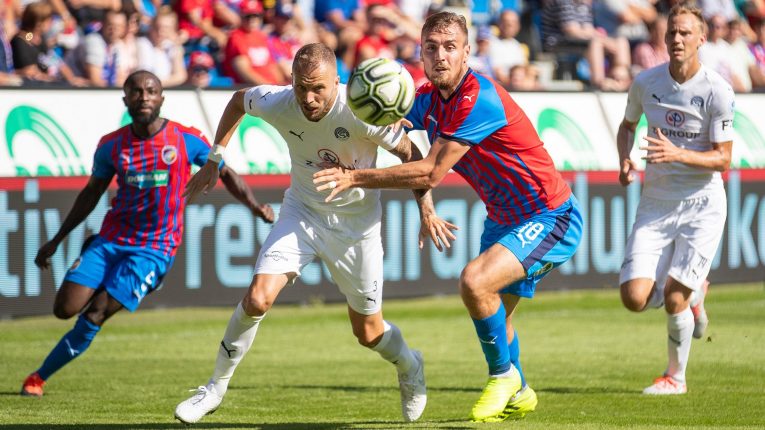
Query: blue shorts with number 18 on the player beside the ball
xmin=481 ymin=194 xmax=582 ymax=298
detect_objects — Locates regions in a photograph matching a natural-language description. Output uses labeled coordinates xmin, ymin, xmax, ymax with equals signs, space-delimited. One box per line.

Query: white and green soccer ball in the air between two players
xmin=347 ymin=58 xmax=415 ymax=125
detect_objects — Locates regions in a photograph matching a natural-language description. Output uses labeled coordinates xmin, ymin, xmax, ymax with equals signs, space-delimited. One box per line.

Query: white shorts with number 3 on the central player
xmin=255 ymin=194 xmax=383 ymax=315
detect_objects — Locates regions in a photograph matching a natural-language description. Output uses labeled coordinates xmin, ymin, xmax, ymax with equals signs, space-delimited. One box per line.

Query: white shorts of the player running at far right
xmin=619 ymin=190 xmax=727 ymax=291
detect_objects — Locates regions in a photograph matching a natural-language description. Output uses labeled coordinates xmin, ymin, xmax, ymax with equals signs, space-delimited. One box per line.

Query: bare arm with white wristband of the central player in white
xmin=183 ymin=90 xmax=246 ymax=202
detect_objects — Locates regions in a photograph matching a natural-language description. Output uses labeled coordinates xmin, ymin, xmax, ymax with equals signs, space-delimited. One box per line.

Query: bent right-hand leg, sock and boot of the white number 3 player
xmin=348 ymin=306 xmax=427 ymax=422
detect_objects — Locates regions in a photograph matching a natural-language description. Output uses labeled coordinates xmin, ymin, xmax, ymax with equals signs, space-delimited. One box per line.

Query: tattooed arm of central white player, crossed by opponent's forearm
xmin=390 ymin=134 xmax=459 ymax=252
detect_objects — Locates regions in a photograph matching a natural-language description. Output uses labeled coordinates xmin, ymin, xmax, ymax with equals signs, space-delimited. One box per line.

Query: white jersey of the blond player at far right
xmin=624 ymin=63 xmax=735 ymax=200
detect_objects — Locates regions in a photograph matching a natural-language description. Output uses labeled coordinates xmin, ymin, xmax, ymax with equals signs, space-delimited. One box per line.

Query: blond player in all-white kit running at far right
xmin=617 ymin=5 xmax=734 ymax=395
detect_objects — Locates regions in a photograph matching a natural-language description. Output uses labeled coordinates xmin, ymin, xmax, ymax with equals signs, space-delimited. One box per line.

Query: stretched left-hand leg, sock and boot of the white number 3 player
xmin=175 ymin=273 xmax=295 ymax=424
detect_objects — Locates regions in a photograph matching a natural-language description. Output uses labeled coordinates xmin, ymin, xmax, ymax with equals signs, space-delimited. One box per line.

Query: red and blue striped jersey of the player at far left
xmin=93 ymin=120 xmax=210 ymax=257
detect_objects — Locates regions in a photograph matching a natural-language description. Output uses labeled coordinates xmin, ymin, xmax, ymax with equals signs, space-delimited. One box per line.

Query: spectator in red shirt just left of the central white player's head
xmin=223 ymin=0 xmax=285 ymax=85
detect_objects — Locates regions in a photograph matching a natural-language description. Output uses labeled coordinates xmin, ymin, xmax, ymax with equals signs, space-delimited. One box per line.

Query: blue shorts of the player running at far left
xmin=64 ymin=236 xmax=174 ymax=312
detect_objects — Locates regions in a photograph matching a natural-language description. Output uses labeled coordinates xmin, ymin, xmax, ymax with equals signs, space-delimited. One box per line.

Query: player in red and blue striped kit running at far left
xmin=21 ymin=71 xmax=274 ymax=397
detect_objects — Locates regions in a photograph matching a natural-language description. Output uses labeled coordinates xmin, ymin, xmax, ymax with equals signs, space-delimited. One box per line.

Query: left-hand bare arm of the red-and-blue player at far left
xmin=35 ymin=176 xmax=112 ymax=269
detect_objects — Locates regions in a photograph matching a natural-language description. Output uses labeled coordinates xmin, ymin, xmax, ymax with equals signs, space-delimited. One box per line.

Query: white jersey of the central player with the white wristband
xmin=244 ymin=84 xmax=404 ymax=216
